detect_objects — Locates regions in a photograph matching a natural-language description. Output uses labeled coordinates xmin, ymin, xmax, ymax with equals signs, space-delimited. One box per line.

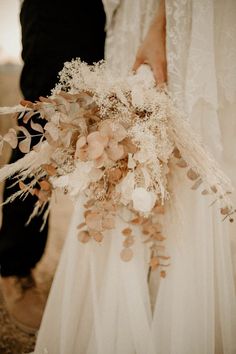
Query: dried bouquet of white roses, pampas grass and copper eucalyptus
xmin=0 ymin=59 xmax=234 ymax=277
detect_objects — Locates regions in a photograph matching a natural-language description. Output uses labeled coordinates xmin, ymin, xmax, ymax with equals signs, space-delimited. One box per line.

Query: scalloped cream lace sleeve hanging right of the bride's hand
xmin=166 ymin=0 xmax=236 ymax=113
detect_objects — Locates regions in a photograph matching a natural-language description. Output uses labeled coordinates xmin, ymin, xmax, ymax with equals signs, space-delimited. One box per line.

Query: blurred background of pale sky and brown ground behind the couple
xmin=0 ymin=0 xmax=72 ymax=354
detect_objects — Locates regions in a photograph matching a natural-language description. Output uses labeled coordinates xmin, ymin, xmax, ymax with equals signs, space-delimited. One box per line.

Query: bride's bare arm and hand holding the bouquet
xmin=133 ymin=0 xmax=167 ymax=84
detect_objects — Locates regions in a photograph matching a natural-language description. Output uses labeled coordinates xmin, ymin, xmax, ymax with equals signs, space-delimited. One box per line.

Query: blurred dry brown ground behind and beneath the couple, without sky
xmin=0 ymin=67 xmax=73 ymax=354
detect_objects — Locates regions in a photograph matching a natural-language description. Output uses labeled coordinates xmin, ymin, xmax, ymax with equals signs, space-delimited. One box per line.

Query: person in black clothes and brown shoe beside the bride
xmin=0 ymin=0 xmax=105 ymax=332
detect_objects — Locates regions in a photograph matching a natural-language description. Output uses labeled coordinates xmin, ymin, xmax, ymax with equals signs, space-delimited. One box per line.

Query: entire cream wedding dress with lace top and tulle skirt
xmin=35 ymin=0 xmax=236 ymax=354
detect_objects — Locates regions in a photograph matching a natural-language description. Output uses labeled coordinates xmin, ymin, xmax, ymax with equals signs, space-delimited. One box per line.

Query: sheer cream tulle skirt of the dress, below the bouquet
xmin=35 ymin=170 xmax=236 ymax=354
